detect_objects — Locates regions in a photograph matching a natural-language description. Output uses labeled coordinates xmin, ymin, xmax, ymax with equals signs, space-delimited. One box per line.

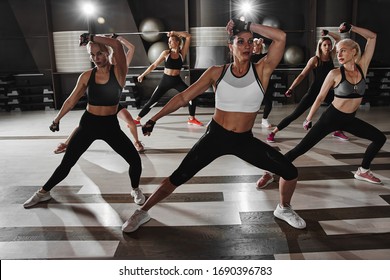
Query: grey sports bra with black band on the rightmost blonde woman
xmin=334 ymin=64 xmax=366 ymax=98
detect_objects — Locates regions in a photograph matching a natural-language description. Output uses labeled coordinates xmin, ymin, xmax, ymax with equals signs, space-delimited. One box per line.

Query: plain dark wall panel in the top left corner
xmin=0 ymin=0 xmax=51 ymax=73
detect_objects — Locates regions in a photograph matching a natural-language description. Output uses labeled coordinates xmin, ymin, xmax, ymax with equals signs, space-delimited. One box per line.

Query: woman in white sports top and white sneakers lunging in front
xmin=122 ymin=19 xmax=306 ymax=232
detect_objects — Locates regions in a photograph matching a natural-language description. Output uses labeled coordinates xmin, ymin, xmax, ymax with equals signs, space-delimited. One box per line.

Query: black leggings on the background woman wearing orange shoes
xmin=138 ymin=74 xmax=196 ymax=118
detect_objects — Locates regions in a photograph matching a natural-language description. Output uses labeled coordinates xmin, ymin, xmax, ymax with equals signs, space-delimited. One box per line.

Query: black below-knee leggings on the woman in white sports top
xmin=169 ymin=119 xmax=298 ymax=187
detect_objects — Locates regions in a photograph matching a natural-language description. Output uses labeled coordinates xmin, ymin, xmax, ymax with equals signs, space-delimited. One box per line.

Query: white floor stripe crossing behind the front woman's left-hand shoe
xmin=0 ymin=202 xmax=241 ymax=227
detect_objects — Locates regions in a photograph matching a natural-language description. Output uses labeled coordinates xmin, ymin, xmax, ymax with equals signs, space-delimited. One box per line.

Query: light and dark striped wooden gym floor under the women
xmin=0 ymin=105 xmax=390 ymax=260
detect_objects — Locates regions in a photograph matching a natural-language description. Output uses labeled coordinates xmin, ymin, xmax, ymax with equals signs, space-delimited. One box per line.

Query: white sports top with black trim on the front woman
xmin=215 ymin=63 xmax=264 ymax=113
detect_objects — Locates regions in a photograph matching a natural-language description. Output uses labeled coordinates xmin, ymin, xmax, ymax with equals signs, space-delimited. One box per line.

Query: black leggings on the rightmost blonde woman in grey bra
xmin=286 ymin=104 xmax=386 ymax=169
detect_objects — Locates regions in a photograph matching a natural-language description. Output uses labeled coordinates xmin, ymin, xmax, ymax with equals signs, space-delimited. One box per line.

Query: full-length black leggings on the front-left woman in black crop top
xmin=43 ymin=111 xmax=142 ymax=191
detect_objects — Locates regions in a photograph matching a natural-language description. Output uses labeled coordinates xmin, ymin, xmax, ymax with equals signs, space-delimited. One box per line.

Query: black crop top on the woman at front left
xmin=87 ymin=65 xmax=122 ymax=106
